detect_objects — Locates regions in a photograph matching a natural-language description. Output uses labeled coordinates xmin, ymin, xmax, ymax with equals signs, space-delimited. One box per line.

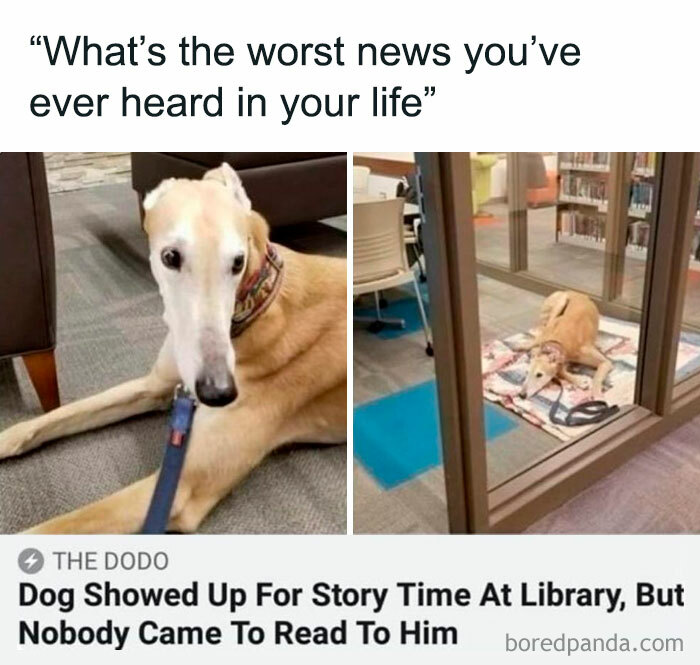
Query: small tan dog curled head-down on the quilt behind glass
xmin=518 ymin=291 xmax=612 ymax=399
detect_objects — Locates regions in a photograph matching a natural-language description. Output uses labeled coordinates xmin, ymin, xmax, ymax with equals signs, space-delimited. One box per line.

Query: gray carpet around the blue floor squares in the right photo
xmin=353 ymin=275 xmax=562 ymax=533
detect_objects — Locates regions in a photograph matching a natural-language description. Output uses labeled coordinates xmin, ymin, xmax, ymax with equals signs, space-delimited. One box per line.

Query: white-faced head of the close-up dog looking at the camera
xmin=143 ymin=164 xmax=268 ymax=406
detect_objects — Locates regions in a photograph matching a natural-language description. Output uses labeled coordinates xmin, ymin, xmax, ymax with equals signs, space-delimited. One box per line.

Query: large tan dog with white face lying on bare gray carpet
xmin=0 ymin=164 xmax=347 ymax=533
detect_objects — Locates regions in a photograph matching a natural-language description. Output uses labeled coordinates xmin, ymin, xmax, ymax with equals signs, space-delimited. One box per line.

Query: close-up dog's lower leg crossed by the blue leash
xmin=26 ymin=378 xmax=347 ymax=534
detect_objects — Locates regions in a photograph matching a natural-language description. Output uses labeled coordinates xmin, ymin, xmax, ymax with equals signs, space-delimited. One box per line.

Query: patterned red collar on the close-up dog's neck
xmin=231 ymin=243 xmax=284 ymax=339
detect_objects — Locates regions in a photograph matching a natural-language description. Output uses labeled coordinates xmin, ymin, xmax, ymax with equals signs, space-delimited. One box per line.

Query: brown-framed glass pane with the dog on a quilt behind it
xmin=417 ymin=153 xmax=700 ymax=531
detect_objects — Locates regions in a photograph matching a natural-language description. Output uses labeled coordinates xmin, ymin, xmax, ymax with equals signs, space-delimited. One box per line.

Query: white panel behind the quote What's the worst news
xmin=0 ymin=0 xmax=698 ymax=151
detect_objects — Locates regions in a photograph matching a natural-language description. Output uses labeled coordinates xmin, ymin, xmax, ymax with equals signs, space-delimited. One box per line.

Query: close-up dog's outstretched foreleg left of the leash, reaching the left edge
xmin=0 ymin=341 xmax=178 ymax=459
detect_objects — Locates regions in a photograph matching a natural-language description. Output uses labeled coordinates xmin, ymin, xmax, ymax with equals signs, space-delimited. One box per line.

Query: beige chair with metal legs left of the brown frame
xmin=352 ymin=198 xmax=433 ymax=356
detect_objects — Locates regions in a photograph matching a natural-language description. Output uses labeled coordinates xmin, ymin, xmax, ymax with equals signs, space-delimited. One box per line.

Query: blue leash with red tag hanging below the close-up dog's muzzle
xmin=141 ymin=385 xmax=195 ymax=534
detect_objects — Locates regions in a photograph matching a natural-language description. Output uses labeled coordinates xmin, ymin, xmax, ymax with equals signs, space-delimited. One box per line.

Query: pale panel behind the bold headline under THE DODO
xmin=0 ymin=536 xmax=700 ymax=665
